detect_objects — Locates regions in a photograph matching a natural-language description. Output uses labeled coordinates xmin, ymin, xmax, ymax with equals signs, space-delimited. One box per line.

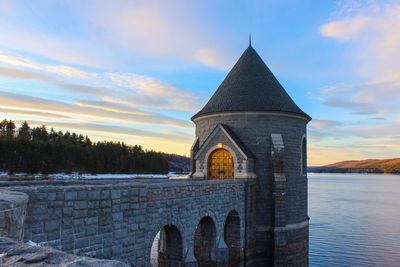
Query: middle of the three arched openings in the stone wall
xmin=194 ymin=216 xmax=216 ymax=267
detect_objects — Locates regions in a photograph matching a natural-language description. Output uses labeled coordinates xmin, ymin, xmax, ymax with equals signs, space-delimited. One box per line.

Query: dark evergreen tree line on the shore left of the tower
xmin=0 ymin=119 xmax=169 ymax=174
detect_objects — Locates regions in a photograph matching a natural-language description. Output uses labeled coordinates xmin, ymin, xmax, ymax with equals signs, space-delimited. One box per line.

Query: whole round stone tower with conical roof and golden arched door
xmin=190 ymin=45 xmax=311 ymax=266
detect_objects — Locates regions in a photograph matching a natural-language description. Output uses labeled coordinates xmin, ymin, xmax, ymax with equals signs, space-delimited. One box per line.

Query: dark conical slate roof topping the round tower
xmin=192 ymin=45 xmax=311 ymax=120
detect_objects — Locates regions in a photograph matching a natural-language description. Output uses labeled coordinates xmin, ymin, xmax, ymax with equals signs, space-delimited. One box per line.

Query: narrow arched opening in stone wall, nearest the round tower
xmin=224 ymin=210 xmax=241 ymax=267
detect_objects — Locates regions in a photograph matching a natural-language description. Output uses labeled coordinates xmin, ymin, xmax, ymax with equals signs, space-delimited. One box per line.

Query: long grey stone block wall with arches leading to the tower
xmin=1 ymin=180 xmax=253 ymax=266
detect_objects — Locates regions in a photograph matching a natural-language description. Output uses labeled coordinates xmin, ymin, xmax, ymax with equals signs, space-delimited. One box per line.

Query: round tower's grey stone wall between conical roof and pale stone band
xmin=195 ymin=114 xmax=307 ymax=225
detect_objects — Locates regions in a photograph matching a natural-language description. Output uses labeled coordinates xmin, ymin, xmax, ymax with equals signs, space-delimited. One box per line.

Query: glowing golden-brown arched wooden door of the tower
xmin=208 ymin=148 xmax=233 ymax=180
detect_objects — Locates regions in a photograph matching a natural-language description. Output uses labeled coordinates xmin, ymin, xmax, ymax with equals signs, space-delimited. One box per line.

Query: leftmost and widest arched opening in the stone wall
xmin=150 ymin=225 xmax=183 ymax=267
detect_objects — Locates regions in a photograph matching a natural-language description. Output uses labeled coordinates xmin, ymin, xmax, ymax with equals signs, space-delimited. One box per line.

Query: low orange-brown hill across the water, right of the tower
xmin=308 ymin=158 xmax=400 ymax=174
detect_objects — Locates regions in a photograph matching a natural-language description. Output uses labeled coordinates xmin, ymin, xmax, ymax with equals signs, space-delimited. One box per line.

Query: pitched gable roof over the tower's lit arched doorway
xmin=194 ymin=123 xmax=256 ymax=159
